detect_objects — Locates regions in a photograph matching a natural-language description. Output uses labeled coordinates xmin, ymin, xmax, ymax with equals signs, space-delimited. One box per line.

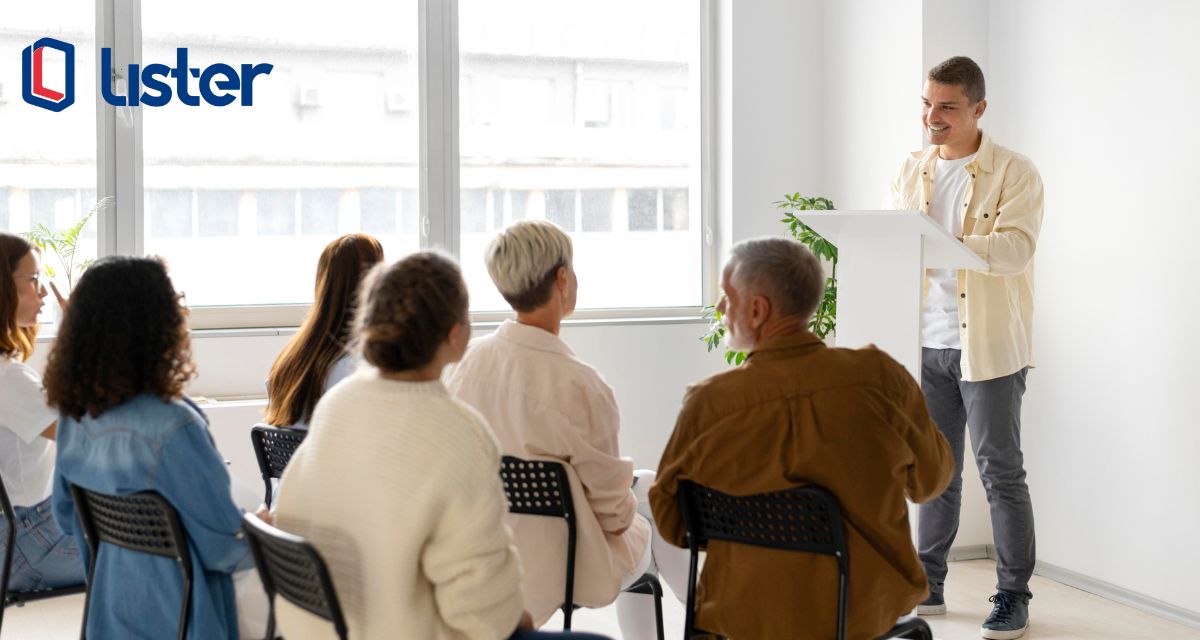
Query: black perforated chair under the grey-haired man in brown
xmin=679 ymin=480 xmax=934 ymax=640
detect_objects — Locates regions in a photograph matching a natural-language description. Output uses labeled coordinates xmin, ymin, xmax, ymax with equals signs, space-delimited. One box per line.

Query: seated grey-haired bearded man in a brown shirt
xmin=650 ymin=238 xmax=954 ymax=639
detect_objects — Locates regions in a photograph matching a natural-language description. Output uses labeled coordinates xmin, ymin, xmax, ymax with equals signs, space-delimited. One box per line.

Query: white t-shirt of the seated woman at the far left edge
xmin=0 ymin=355 xmax=59 ymax=507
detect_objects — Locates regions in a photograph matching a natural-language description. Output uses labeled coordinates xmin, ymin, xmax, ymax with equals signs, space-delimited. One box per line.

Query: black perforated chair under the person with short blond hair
xmin=500 ymin=455 xmax=664 ymax=640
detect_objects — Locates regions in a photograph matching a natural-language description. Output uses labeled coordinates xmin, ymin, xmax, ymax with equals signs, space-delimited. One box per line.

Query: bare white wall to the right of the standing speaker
xmin=989 ymin=0 xmax=1200 ymax=612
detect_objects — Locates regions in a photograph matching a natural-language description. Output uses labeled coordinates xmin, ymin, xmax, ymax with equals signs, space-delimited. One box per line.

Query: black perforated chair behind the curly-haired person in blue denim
xmin=71 ymin=484 xmax=193 ymax=640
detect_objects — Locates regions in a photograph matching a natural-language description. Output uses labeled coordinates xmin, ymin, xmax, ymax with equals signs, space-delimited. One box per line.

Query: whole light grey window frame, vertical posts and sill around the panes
xmin=96 ymin=0 xmax=718 ymax=329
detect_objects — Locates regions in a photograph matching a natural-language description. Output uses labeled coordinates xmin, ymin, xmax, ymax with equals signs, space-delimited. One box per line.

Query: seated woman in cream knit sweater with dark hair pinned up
xmin=276 ymin=252 xmax=609 ymax=640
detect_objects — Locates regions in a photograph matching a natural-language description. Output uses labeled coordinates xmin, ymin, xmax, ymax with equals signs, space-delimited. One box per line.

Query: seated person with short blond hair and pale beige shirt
xmin=448 ymin=221 xmax=688 ymax=640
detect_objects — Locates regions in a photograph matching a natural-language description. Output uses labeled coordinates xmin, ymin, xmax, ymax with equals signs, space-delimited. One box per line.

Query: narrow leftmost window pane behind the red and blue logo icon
xmin=0 ymin=0 xmax=97 ymax=304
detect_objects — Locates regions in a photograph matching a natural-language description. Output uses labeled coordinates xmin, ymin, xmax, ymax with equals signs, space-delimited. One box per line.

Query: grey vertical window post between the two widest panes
xmin=418 ymin=0 xmax=458 ymax=257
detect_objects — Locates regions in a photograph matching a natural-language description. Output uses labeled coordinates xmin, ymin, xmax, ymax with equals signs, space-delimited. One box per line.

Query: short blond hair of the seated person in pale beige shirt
xmin=484 ymin=220 xmax=571 ymax=312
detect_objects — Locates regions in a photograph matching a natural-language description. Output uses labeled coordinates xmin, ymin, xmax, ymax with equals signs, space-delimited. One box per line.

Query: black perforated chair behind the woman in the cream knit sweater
xmin=241 ymin=514 xmax=348 ymax=640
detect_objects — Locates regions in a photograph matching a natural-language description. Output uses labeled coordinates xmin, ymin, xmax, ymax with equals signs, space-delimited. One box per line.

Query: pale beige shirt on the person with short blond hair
xmin=446 ymin=321 xmax=649 ymax=624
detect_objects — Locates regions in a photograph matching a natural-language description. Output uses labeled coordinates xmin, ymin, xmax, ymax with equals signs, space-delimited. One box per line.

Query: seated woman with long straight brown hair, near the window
xmin=266 ymin=233 xmax=383 ymax=429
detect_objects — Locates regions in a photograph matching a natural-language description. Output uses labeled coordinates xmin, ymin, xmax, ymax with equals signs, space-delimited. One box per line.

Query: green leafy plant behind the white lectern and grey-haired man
xmin=701 ymin=193 xmax=838 ymax=365
